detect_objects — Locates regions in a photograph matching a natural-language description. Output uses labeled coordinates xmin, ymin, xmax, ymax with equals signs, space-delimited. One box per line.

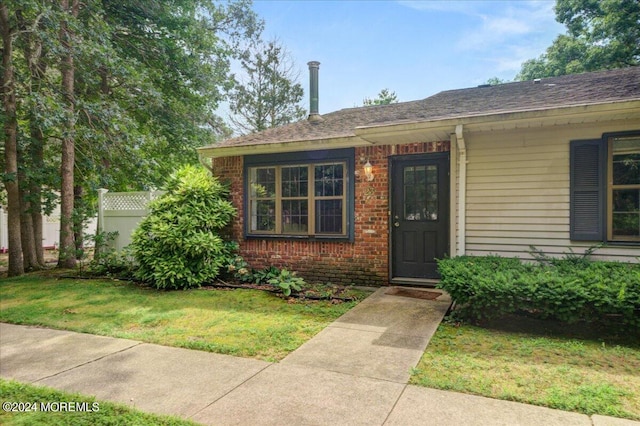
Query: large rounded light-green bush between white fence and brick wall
xmin=130 ymin=166 xmax=236 ymax=289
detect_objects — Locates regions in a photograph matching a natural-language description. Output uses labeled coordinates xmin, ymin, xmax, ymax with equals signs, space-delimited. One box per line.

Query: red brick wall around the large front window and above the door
xmin=213 ymin=141 xmax=449 ymax=286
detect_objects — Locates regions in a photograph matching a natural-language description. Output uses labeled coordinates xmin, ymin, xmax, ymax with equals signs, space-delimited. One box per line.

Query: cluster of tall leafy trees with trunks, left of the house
xmin=0 ymin=0 xmax=263 ymax=275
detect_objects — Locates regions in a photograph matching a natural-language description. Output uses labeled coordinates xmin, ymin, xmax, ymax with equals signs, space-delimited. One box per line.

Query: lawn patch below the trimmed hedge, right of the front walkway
xmin=411 ymin=323 xmax=640 ymax=420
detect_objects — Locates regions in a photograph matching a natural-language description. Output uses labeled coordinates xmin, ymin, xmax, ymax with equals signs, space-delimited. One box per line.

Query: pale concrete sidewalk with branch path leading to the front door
xmin=0 ymin=288 xmax=640 ymax=426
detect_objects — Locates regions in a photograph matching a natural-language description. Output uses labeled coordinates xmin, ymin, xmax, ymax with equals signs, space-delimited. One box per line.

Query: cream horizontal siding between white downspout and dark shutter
xmin=465 ymin=123 xmax=640 ymax=261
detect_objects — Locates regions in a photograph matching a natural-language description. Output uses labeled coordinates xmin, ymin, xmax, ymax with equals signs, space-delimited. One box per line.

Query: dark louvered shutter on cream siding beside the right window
xmin=570 ymin=139 xmax=606 ymax=241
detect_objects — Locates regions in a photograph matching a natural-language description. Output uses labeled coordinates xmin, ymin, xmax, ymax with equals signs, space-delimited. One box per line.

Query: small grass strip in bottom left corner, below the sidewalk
xmin=0 ymin=379 xmax=197 ymax=426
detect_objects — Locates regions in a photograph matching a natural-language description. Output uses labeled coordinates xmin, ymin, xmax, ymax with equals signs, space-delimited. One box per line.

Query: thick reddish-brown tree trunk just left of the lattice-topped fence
xmin=58 ymin=0 xmax=78 ymax=268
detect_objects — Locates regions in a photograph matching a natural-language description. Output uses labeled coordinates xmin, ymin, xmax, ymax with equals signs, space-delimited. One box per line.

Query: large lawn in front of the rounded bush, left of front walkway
xmin=0 ymin=275 xmax=356 ymax=361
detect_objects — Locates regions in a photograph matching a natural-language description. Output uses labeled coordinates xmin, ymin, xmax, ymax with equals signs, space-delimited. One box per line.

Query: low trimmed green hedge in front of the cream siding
xmin=438 ymin=256 xmax=640 ymax=327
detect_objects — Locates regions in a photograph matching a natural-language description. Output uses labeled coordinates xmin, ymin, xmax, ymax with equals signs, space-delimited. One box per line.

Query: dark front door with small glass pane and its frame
xmin=390 ymin=153 xmax=449 ymax=279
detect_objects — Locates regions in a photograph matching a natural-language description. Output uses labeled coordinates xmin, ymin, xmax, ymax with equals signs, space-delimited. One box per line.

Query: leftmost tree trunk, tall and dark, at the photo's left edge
xmin=0 ymin=2 xmax=24 ymax=277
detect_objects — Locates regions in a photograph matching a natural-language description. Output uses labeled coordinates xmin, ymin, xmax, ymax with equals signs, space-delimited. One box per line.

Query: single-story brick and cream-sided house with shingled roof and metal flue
xmin=199 ymin=63 xmax=640 ymax=285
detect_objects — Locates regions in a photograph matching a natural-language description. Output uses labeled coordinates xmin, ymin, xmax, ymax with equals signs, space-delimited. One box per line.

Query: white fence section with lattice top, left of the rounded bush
xmin=98 ymin=189 xmax=164 ymax=252
